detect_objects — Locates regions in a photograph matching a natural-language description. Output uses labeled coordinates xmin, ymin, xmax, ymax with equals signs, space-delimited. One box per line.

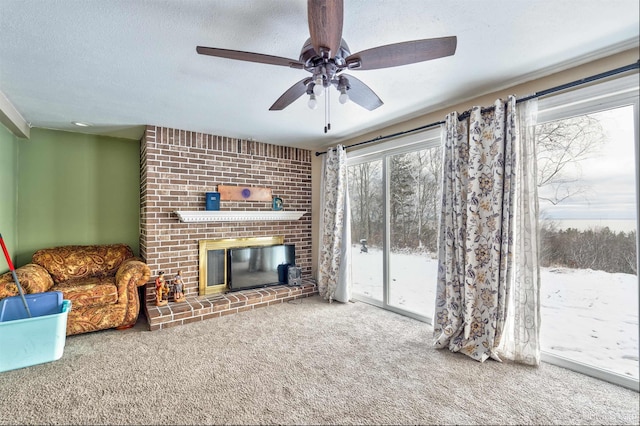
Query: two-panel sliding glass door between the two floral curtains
xmin=349 ymin=130 xmax=442 ymax=321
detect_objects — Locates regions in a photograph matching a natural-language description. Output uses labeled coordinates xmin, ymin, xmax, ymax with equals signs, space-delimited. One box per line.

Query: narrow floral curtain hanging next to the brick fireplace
xmin=318 ymin=145 xmax=351 ymax=302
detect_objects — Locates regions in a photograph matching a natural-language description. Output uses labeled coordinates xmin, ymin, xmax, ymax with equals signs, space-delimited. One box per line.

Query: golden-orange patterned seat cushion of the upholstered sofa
xmin=54 ymin=277 xmax=118 ymax=309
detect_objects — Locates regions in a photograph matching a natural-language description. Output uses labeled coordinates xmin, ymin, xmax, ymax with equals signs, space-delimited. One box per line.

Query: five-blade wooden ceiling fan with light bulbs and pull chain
xmin=196 ymin=0 xmax=457 ymax=122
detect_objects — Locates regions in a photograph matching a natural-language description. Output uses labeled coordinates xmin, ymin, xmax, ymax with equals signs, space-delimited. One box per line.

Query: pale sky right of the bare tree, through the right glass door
xmin=540 ymin=106 xmax=636 ymax=220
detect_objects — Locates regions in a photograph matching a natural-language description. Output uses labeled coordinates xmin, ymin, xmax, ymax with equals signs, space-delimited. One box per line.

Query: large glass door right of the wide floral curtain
xmin=536 ymin=75 xmax=639 ymax=389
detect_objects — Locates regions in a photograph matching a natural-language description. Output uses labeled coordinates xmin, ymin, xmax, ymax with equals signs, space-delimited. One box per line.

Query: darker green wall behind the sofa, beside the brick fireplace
xmin=16 ymin=129 xmax=140 ymax=266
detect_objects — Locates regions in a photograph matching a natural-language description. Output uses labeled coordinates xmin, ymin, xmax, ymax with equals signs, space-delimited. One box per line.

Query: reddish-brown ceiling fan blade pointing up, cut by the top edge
xmin=307 ymin=0 xmax=344 ymax=57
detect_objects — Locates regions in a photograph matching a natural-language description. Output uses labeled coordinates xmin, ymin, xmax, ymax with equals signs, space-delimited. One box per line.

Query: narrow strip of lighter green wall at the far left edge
xmin=0 ymin=124 xmax=20 ymax=274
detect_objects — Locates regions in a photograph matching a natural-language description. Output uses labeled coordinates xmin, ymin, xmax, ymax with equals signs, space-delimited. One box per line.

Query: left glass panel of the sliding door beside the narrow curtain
xmin=348 ymin=160 xmax=384 ymax=305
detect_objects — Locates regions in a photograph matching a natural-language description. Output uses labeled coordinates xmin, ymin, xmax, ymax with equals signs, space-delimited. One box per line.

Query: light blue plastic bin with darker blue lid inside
xmin=0 ymin=292 xmax=71 ymax=372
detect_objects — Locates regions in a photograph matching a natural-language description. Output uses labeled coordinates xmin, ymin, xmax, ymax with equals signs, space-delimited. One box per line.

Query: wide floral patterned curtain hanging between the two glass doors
xmin=434 ymin=97 xmax=538 ymax=362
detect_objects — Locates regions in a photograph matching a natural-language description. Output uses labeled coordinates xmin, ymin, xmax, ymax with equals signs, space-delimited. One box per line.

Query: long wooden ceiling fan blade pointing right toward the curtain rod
xmin=346 ymin=36 xmax=458 ymax=70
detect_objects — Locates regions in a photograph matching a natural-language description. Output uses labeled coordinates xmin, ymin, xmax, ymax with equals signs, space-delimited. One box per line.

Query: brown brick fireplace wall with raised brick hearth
xmin=140 ymin=126 xmax=317 ymax=330
